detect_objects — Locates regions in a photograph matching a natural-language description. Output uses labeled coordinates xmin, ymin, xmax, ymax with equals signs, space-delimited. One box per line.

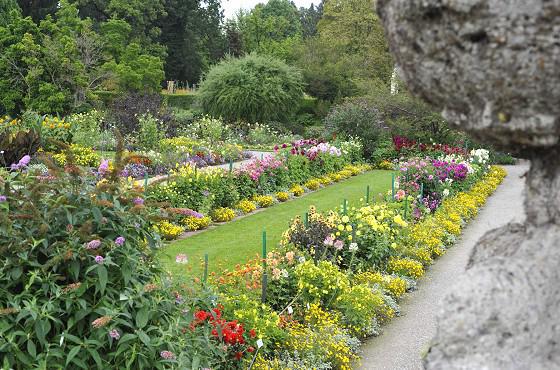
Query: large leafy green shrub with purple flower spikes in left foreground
xmin=0 ymin=162 xmax=186 ymax=369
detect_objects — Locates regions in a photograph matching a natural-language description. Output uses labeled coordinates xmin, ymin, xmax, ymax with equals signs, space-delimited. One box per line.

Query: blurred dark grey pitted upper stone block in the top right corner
xmin=378 ymin=0 xmax=560 ymax=150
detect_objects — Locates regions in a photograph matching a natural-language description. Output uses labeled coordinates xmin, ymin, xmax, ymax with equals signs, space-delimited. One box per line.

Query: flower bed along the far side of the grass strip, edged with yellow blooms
xmin=148 ymin=142 xmax=370 ymax=239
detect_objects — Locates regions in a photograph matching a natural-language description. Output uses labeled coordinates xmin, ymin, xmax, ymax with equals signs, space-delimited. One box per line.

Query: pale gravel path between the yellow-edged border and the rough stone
xmin=361 ymin=163 xmax=529 ymax=370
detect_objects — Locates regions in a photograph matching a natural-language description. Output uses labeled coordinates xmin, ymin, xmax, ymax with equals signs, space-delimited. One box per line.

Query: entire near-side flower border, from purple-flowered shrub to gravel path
xmin=0 ymin=141 xmax=505 ymax=369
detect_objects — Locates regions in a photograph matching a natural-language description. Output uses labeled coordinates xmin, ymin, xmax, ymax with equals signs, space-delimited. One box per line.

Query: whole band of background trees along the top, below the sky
xmin=0 ymin=0 xmax=393 ymax=114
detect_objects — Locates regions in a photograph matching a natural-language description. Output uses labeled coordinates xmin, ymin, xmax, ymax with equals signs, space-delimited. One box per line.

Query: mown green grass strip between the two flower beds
xmin=160 ymin=171 xmax=391 ymax=276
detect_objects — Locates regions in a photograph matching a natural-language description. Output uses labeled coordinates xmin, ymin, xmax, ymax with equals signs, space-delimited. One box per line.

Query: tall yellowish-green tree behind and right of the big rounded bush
xmin=297 ymin=0 xmax=393 ymax=101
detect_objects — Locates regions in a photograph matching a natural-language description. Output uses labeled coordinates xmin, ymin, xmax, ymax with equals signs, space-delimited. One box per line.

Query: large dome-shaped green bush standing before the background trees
xmin=198 ymin=54 xmax=303 ymax=122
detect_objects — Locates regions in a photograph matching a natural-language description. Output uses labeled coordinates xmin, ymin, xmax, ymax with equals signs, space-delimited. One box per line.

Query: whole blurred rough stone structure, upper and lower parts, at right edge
xmin=378 ymin=0 xmax=560 ymax=369
